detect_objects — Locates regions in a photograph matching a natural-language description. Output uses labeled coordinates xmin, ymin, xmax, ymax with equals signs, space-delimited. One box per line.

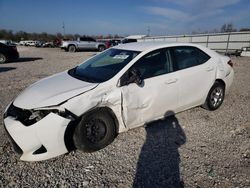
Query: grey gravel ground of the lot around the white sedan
xmin=0 ymin=47 xmax=250 ymax=188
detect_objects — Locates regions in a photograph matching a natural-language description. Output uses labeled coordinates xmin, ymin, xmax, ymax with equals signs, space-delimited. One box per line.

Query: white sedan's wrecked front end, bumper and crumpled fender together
xmin=4 ymin=84 xmax=127 ymax=161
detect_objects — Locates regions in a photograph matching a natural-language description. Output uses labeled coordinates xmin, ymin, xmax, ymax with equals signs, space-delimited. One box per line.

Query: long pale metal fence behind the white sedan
xmin=139 ymin=31 xmax=250 ymax=52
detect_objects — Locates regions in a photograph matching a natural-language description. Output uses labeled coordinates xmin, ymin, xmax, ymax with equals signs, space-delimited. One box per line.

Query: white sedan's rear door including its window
xmin=172 ymin=46 xmax=216 ymax=110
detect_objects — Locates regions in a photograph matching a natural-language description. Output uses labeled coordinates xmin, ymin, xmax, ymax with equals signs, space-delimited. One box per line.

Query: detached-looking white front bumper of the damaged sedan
xmin=4 ymin=113 xmax=70 ymax=161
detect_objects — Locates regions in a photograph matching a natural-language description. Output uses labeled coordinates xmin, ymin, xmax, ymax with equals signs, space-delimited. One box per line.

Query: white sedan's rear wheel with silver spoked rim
xmin=202 ymin=81 xmax=225 ymax=111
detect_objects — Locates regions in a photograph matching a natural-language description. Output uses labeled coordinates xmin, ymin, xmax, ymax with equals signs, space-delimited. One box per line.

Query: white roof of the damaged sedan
xmin=113 ymin=41 xmax=203 ymax=52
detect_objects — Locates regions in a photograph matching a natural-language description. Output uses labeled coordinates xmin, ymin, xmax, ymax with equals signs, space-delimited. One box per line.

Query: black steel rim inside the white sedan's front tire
xmin=86 ymin=119 xmax=106 ymax=143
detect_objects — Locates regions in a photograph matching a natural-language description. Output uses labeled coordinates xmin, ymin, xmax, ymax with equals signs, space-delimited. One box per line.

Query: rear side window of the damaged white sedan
xmin=173 ymin=47 xmax=210 ymax=70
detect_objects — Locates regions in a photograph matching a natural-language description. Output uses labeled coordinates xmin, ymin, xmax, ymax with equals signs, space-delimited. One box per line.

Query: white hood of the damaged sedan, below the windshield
xmin=13 ymin=72 xmax=98 ymax=109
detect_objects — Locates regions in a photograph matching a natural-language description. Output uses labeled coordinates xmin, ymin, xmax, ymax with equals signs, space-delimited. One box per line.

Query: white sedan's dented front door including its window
xmin=120 ymin=49 xmax=179 ymax=128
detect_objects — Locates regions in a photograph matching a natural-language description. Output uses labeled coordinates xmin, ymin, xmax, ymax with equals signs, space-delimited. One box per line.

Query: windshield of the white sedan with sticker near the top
xmin=69 ymin=48 xmax=140 ymax=83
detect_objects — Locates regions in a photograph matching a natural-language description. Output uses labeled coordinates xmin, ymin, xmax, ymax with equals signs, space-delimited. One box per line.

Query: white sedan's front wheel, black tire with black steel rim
xmin=73 ymin=109 xmax=116 ymax=152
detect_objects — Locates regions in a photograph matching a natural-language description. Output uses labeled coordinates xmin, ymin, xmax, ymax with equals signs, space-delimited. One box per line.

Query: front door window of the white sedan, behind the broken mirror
xmin=132 ymin=49 xmax=173 ymax=79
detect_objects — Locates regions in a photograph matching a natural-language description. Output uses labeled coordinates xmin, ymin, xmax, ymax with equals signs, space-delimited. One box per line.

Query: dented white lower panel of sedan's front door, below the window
xmin=121 ymin=72 xmax=179 ymax=128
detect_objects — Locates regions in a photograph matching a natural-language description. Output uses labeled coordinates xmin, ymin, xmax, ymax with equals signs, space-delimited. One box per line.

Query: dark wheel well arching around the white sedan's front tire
xmin=64 ymin=107 xmax=119 ymax=151
